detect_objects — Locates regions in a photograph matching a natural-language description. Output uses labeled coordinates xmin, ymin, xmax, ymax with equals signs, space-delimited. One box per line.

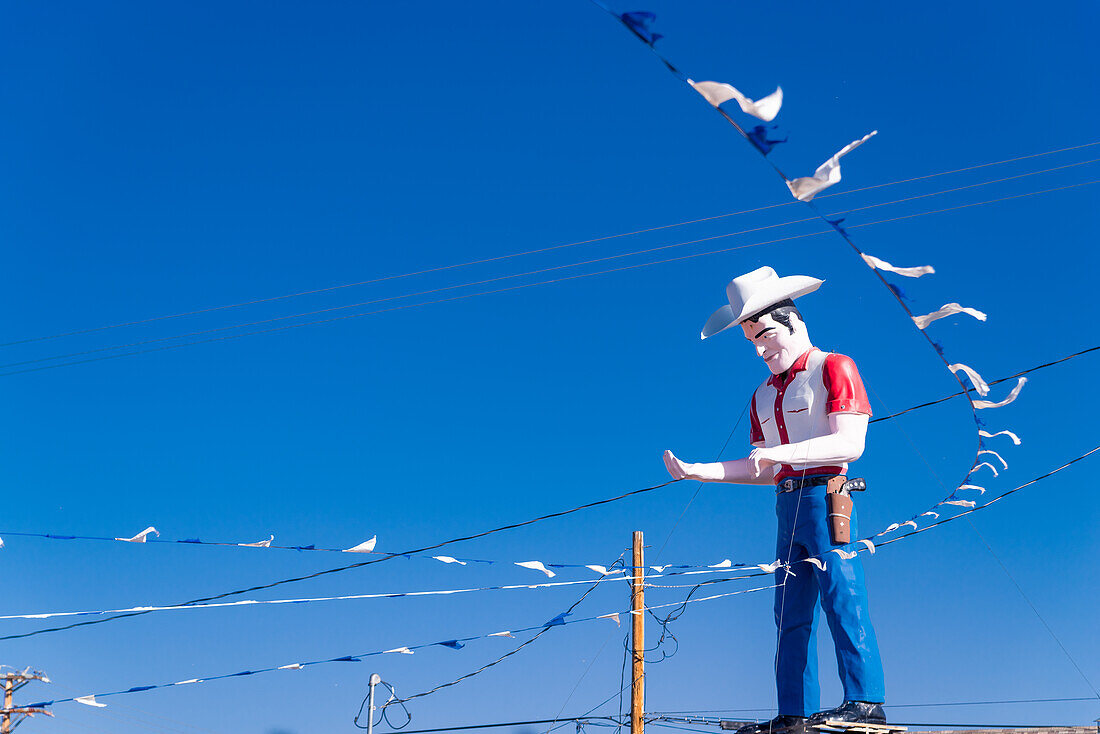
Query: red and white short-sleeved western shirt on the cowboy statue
xmin=749 ymin=347 xmax=871 ymax=484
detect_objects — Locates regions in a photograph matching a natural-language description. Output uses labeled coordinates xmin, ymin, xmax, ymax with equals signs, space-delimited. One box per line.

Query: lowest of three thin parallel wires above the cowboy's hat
xmin=0 ymin=179 xmax=1100 ymax=378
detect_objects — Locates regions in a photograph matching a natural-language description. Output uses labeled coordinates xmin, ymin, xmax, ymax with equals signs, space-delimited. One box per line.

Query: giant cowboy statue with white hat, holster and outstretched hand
xmin=664 ymin=267 xmax=886 ymax=734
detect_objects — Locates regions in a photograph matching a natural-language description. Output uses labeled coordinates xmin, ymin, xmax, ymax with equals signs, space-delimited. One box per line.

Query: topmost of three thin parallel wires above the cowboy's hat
xmin=0 ymin=141 xmax=1100 ymax=347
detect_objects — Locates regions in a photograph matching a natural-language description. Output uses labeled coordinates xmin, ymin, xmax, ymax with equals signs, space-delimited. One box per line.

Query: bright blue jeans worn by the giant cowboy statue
xmin=776 ymin=486 xmax=886 ymax=716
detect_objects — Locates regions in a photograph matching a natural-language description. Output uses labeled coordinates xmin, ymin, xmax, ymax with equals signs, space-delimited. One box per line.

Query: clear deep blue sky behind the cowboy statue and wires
xmin=0 ymin=2 xmax=1100 ymax=734
